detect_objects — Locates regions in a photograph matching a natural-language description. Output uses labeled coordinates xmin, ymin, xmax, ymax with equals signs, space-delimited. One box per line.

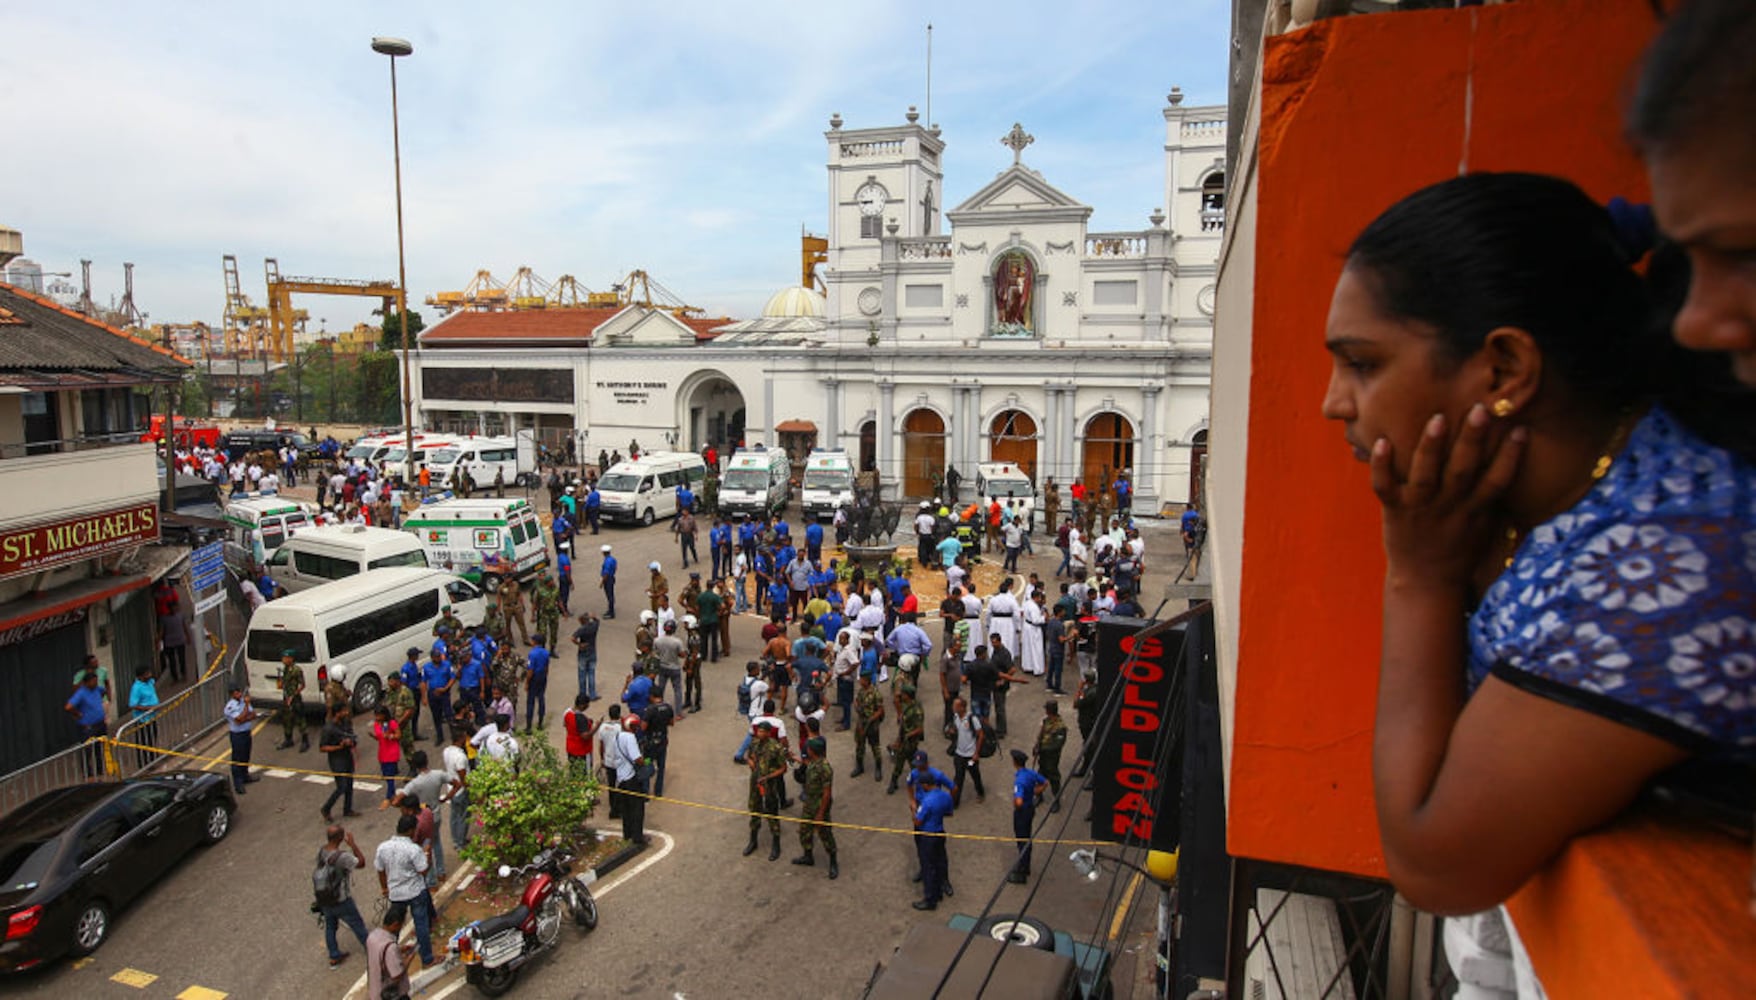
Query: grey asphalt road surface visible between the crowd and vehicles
xmin=11 ymin=495 xmax=1180 ymax=1000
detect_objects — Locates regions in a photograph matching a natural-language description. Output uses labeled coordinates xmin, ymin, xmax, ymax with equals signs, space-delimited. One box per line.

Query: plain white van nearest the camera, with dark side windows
xmin=244 ymin=566 xmax=485 ymax=714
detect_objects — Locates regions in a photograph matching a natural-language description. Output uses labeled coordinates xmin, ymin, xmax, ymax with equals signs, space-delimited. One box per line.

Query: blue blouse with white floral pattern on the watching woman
xmin=1468 ymin=408 xmax=1756 ymax=761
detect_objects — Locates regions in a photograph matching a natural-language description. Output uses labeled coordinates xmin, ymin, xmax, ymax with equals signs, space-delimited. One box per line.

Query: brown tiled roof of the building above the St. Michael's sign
xmin=0 ymin=283 xmax=190 ymax=378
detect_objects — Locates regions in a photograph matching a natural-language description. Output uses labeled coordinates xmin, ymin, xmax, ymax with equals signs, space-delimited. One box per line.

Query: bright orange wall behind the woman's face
xmin=1227 ymin=0 xmax=1654 ymax=875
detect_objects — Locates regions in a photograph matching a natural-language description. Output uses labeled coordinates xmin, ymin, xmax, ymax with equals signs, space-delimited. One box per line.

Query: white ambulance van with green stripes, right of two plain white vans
xmin=402 ymin=497 xmax=548 ymax=592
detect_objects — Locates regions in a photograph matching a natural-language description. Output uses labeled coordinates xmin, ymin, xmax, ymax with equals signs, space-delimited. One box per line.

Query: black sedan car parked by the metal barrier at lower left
xmin=0 ymin=772 xmax=237 ymax=972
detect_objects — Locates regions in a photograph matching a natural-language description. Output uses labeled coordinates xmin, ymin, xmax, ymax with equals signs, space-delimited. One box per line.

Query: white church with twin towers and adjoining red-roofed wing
xmin=414 ymin=90 xmax=1226 ymax=511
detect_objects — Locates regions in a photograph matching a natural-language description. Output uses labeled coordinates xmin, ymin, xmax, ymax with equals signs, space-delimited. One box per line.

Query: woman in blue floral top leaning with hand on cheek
xmin=1322 ymin=174 xmax=1756 ymax=914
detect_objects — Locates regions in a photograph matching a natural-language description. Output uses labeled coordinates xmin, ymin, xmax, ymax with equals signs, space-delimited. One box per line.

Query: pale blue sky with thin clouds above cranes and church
xmin=0 ymin=0 xmax=1229 ymax=329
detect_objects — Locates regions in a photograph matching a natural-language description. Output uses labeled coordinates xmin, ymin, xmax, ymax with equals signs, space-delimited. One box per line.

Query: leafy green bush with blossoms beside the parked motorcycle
xmin=464 ymin=738 xmax=599 ymax=872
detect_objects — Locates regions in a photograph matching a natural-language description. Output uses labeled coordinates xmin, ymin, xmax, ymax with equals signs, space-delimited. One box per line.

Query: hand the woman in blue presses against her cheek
xmin=1371 ymin=404 xmax=1528 ymax=587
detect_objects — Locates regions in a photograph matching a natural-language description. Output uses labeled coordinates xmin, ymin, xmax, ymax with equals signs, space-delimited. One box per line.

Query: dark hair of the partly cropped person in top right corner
xmin=1626 ymin=0 xmax=1756 ymax=153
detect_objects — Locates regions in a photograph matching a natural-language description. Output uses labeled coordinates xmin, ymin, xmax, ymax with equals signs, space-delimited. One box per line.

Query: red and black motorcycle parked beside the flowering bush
xmin=448 ymin=849 xmax=597 ymax=996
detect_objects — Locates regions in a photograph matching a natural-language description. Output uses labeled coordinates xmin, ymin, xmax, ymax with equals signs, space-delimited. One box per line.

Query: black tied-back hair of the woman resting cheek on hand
xmin=1347 ymin=174 xmax=1756 ymax=459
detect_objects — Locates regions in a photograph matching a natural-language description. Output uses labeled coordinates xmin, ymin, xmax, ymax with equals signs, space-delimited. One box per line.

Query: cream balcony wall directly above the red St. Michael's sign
xmin=0 ymin=441 xmax=158 ymax=529
